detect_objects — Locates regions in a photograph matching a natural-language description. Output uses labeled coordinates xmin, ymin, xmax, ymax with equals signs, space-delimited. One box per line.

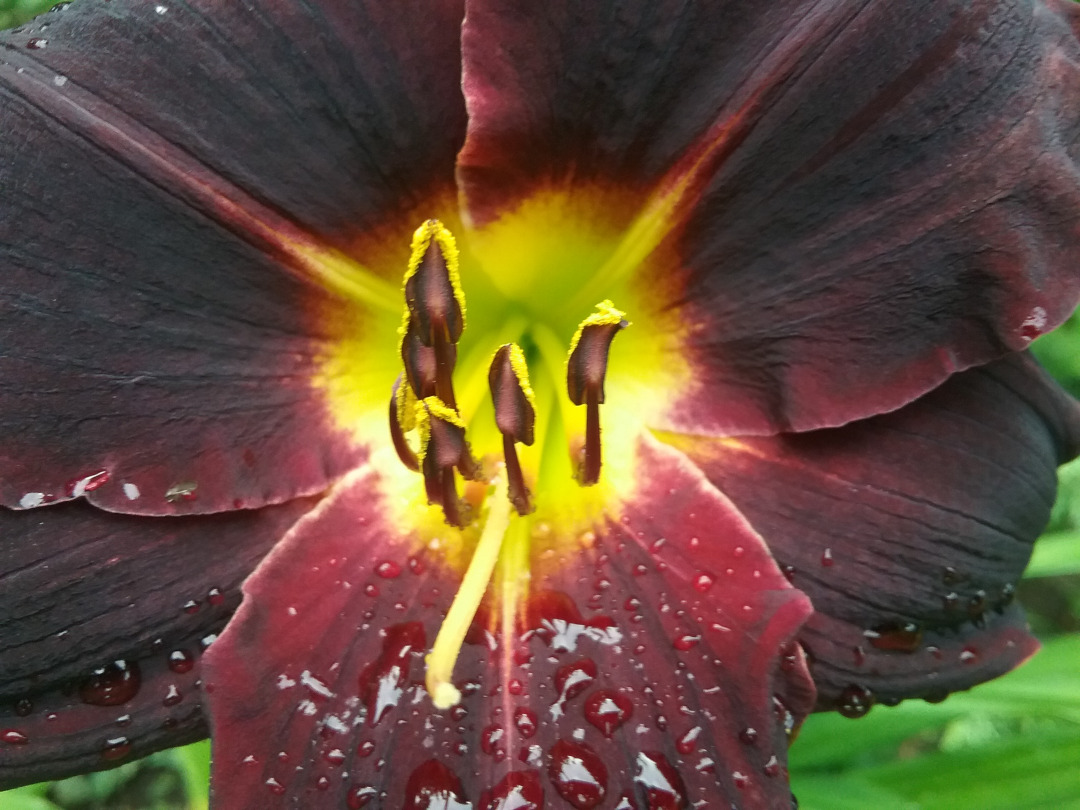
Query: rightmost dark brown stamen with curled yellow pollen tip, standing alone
xmin=566 ymin=300 xmax=630 ymax=486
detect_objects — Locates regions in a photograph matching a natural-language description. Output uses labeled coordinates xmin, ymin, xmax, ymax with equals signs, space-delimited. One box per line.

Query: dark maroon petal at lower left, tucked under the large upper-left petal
xmin=0 ymin=501 xmax=312 ymax=788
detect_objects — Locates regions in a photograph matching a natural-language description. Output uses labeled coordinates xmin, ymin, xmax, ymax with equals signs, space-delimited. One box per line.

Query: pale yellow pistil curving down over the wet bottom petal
xmin=424 ymin=475 xmax=510 ymax=708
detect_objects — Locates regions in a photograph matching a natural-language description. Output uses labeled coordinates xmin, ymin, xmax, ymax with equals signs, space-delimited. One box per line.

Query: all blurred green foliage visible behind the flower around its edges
xmin=0 ymin=0 xmax=1080 ymax=810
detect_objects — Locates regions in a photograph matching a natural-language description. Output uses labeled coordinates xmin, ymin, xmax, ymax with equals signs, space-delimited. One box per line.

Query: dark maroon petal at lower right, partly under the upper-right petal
xmin=676 ymin=355 xmax=1080 ymax=707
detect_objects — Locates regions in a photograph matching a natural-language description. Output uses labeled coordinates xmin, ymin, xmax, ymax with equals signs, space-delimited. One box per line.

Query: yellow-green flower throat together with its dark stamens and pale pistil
xmin=313 ymin=190 xmax=688 ymax=707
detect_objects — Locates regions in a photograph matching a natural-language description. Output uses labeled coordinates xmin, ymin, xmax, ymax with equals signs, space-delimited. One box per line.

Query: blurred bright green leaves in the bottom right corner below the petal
xmin=789 ymin=636 xmax=1080 ymax=810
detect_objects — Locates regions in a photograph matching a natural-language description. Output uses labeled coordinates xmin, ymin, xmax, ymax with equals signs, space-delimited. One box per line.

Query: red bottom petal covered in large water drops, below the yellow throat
xmin=205 ymin=443 xmax=813 ymax=810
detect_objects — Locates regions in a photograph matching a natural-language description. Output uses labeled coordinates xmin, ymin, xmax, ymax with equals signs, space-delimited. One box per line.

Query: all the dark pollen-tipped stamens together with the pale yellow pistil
xmin=389 ymin=219 xmax=629 ymax=708
